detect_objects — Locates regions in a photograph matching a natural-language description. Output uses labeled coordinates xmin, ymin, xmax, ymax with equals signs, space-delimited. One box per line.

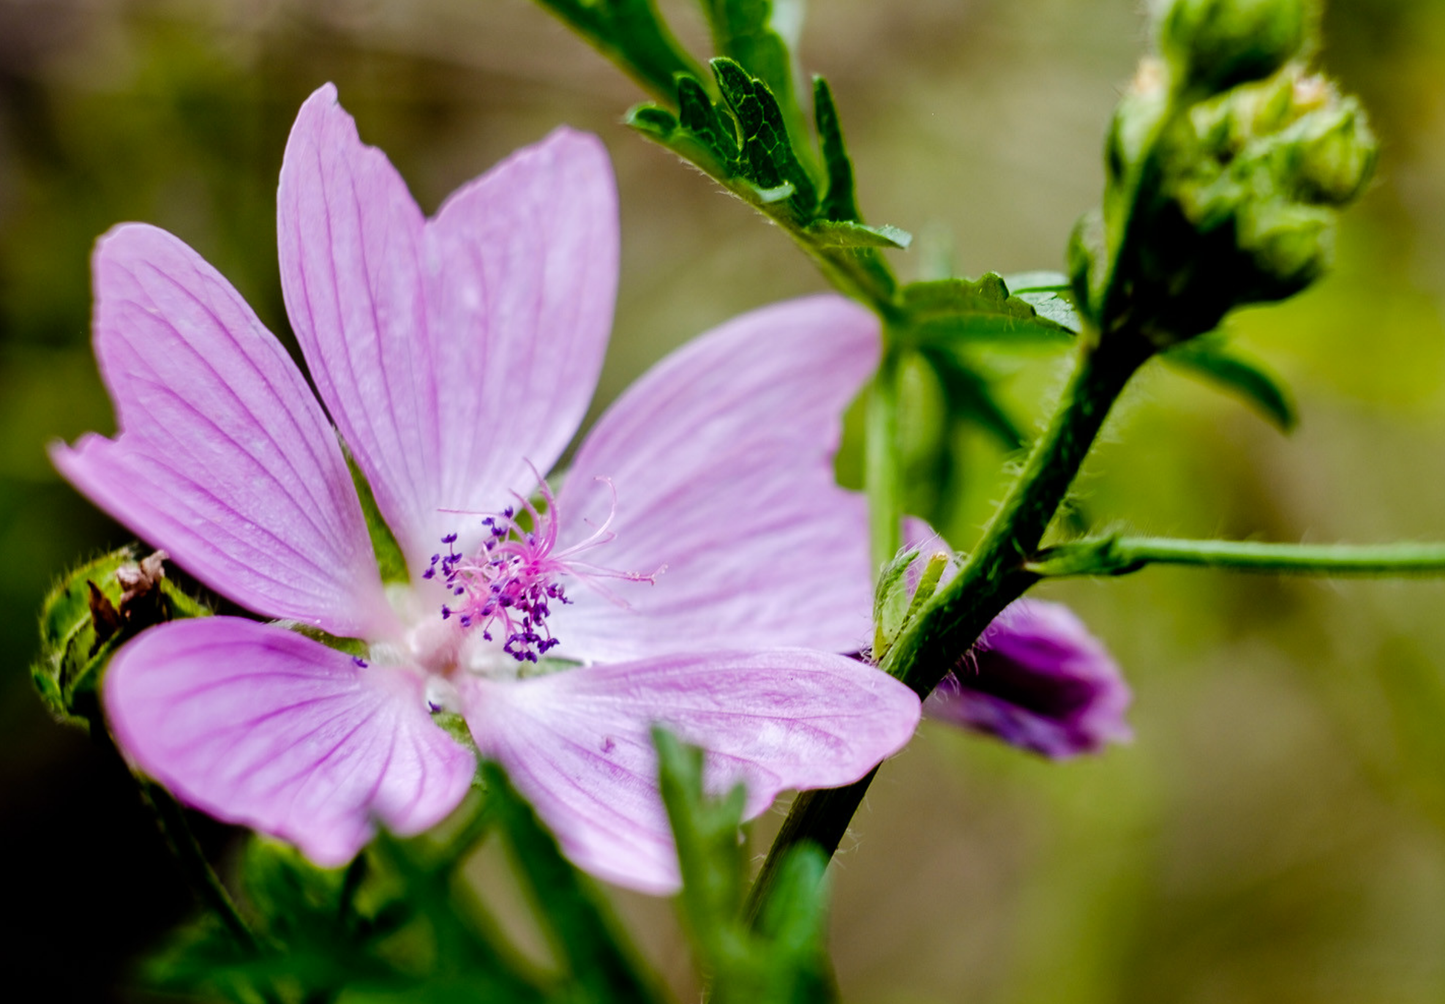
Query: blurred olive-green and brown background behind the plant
xmin=0 ymin=0 xmax=1445 ymax=1004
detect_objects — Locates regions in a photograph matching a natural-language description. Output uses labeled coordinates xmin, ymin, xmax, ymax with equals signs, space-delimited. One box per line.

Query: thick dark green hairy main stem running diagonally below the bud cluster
xmin=747 ymin=331 xmax=1153 ymax=916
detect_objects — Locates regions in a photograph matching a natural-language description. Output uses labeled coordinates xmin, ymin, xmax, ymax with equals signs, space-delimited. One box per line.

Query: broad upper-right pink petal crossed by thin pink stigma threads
xmin=552 ymin=296 xmax=879 ymax=660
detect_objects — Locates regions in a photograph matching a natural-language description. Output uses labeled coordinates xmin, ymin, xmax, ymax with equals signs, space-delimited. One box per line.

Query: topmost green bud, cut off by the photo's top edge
xmin=1159 ymin=0 xmax=1306 ymax=94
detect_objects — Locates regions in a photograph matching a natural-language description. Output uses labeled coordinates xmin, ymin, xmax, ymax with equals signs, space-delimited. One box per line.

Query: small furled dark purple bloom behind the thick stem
xmin=923 ymin=600 xmax=1133 ymax=760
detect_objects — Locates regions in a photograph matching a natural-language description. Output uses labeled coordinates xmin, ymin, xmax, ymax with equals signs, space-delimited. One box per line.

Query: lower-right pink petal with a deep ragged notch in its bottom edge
xmin=462 ymin=650 xmax=919 ymax=894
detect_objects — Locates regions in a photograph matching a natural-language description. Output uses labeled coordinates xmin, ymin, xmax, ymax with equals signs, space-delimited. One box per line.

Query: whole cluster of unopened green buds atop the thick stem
xmin=1072 ymin=0 xmax=1377 ymax=345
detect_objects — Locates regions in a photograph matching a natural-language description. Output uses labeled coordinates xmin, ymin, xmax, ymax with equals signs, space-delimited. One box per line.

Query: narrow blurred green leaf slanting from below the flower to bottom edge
xmin=483 ymin=763 xmax=657 ymax=1004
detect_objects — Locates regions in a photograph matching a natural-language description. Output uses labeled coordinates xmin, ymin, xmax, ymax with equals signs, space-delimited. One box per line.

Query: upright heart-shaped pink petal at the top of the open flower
xmin=277 ymin=84 xmax=617 ymax=571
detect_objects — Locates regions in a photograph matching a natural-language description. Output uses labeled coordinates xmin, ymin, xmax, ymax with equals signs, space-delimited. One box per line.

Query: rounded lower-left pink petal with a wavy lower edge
xmin=104 ymin=617 xmax=475 ymax=867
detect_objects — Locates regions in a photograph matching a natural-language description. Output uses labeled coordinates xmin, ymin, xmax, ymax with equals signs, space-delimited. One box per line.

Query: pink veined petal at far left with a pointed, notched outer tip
xmin=51 ymin=224 xmax=387 ymax=636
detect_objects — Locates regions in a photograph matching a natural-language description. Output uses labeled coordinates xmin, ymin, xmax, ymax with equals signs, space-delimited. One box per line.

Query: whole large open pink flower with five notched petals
xmin=52 ymin=85 xmax=919 ymax=891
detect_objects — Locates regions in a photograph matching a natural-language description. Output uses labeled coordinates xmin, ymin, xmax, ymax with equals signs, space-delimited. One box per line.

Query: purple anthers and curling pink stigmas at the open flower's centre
xmin=422 ymin=471 xmax=666 ymax=663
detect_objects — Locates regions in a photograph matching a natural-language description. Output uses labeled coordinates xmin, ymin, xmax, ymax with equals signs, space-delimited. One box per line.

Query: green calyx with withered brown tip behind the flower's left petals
xmin=30 ymin=546 xmax=211 ymax=728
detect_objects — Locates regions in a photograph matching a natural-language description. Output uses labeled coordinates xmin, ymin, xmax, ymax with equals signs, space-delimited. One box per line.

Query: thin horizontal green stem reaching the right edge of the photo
xmin=1025 ymin=537 xmax=1445 ymax=576
